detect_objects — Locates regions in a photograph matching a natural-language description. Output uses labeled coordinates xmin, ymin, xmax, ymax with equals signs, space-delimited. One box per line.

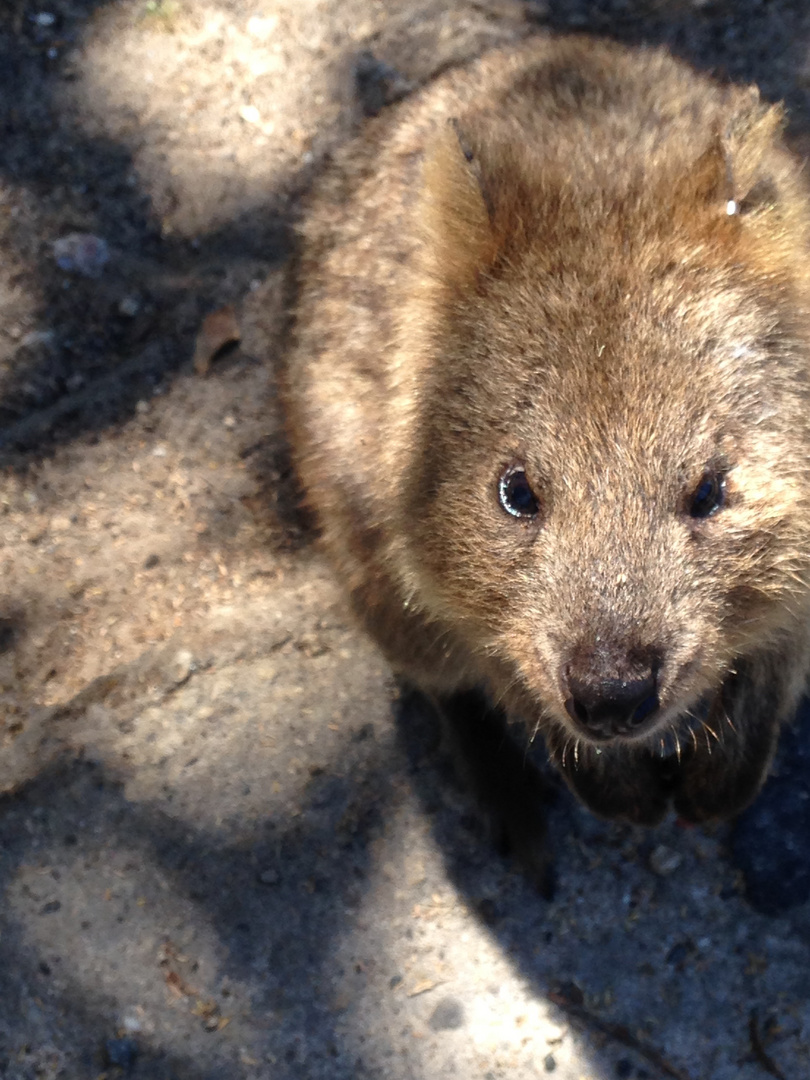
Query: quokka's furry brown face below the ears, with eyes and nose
xmin=404 ymin=227 xmax=810 ymax=744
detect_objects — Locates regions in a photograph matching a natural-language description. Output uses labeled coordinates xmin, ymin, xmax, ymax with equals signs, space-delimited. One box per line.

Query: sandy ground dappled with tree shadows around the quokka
xmin=0 ymin=0 xmax=810 ymax=1080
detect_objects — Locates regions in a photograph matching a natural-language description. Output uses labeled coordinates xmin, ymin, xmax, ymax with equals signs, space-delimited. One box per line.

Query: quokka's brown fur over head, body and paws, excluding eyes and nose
xmin=285 ymin=39 xmax=810 ymax=851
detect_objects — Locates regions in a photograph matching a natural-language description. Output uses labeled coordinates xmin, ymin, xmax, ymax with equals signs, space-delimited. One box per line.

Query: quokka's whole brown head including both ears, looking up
xmin=401 ymin=82 xmax=810 ymax=744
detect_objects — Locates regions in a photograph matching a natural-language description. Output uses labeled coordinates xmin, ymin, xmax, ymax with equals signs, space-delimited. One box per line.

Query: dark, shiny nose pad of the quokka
xmin=565 ymin=670 xmax=659 ymax=739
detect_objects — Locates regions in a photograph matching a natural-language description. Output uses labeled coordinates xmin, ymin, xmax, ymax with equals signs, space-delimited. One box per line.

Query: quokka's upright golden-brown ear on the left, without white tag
xmin=421 ymin=122 xmax=497 ymax=288
